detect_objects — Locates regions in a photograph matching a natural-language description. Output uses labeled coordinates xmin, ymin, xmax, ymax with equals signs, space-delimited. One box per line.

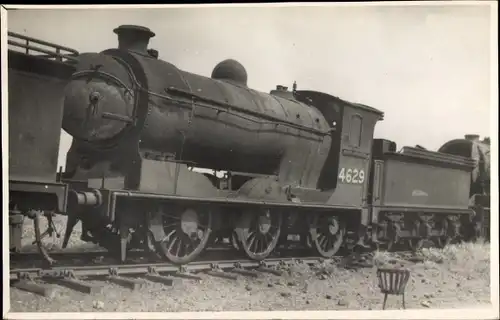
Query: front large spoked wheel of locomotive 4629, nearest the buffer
xmin=159 ymin=208 xmax=212 ymax=264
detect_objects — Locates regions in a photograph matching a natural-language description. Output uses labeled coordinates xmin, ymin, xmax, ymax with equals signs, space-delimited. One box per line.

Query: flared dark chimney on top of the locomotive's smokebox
xmin=113 ymin=25 xmax=155 ymax=55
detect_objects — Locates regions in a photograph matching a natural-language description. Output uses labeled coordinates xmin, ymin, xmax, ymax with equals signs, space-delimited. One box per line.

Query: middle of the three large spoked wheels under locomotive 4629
xmin=235 ymin=210 xmax=283 ymax=260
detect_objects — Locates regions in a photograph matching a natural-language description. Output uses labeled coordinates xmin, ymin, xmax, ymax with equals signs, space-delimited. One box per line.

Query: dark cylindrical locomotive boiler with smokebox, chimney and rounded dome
xmin=63 ymin=26 xmax=331 ymax=188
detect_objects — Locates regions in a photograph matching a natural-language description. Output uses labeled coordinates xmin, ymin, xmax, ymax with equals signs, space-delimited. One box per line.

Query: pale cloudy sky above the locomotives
xmin=7 ymin=5 xmax=496 ymax=170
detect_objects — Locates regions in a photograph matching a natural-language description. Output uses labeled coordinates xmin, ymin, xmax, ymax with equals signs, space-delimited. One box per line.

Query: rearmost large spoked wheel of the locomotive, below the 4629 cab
xmin=309 ymin=214 xmax=346 ymax=258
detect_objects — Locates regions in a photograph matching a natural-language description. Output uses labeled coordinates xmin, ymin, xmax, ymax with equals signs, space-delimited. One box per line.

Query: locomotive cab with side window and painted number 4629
xmin=296 ymin=91 xmax=383 ymax=207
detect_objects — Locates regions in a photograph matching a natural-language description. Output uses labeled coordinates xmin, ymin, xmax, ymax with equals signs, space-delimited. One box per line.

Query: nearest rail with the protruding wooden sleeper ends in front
xmin=10 ymin=257 xmax=332 ymax=297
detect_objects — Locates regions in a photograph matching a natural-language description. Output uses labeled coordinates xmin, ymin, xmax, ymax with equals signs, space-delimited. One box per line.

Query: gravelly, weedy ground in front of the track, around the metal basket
xmin=6 ymin=216 xmax=490 ymax=312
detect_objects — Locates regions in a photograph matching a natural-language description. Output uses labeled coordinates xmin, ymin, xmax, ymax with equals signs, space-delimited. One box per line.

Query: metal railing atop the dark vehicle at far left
xmin=8 ymin=31 xmax=79 ymax=62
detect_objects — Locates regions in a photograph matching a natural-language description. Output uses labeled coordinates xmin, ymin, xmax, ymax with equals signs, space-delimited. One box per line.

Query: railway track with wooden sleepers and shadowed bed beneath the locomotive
xmin=10 ymin=230 xmax=428 ymax=298
